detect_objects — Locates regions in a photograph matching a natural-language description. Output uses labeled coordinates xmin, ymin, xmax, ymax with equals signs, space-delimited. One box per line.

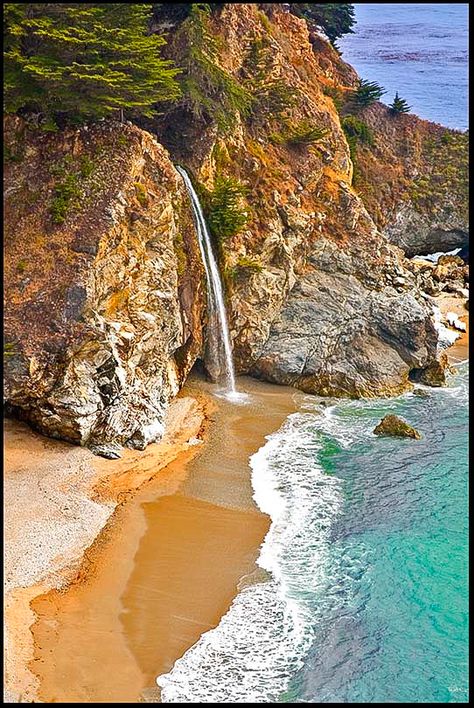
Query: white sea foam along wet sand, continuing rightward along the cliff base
xmin=157 ymin=364 xmax=468 ymax=703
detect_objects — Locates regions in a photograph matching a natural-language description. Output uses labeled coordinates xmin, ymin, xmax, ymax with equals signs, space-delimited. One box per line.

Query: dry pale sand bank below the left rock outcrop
xmin=4 ymin=396 xmax=205 ymax=702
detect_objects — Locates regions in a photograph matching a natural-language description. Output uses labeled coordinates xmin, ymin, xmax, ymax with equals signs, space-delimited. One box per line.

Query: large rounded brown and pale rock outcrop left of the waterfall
xmin=4 ymin=119 xmax=205 ymax=456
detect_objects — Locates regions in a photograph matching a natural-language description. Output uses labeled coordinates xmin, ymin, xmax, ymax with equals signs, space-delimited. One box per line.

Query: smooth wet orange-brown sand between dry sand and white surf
xmin=30 ymin=378 xmax=304 ymax=703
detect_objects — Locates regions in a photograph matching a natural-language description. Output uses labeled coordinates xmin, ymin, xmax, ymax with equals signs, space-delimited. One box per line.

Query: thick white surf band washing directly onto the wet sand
xmin=157 ymin=413 xmax=342 ymax=703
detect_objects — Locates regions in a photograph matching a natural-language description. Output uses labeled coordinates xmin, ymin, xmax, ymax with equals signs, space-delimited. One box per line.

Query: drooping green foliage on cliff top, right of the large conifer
xmin=174 ymin=3 xmax=252 ymax=131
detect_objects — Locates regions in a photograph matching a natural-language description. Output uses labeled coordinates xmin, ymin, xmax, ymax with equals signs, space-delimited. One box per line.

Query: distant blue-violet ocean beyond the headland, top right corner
xmin=337 ymin=3 xmax=468 ymax=130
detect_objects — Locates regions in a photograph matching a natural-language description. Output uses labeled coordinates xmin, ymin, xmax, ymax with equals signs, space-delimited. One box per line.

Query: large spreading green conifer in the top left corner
xmin=4 ymin=3 xmax=179 ymax=121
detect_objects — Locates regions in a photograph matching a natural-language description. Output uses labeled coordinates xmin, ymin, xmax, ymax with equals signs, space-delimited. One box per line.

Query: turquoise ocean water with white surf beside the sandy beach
xmin=158 ymin=363 xmax=468 ymax=703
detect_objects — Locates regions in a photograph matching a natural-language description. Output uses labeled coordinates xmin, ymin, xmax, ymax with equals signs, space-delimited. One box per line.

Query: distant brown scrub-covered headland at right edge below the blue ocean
xmin=338 ymin=103 xmax=469 ymax=258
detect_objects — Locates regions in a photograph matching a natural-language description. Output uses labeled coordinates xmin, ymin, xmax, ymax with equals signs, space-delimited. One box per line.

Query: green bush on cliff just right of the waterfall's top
xmin=197 ymin=177 xmax=248 ymax=242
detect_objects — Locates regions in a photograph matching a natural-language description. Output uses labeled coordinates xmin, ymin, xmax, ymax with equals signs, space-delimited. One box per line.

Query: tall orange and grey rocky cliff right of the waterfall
xmin=154 ymin=4 xmax=444 ymax=396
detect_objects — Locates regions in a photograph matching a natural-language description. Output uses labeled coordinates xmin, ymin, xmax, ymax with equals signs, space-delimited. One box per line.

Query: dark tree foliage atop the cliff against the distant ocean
xmin=290 ymin=2 xmax=356 ymax=44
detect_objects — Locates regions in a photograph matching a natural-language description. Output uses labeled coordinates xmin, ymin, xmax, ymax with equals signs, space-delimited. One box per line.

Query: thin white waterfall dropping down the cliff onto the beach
xmin=176 ymin=167 xmax=236 ymax=394
